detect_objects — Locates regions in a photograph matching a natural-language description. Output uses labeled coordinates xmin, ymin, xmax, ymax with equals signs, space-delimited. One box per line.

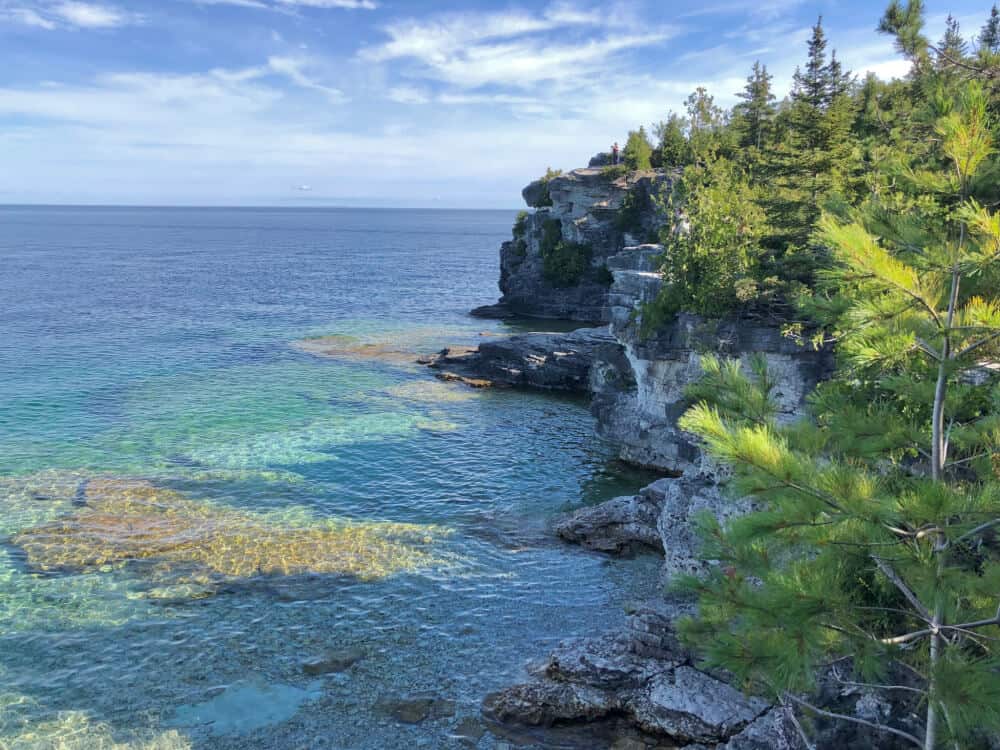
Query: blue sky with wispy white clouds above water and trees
xmin=0 ymin=0 xmax=989 ymax=208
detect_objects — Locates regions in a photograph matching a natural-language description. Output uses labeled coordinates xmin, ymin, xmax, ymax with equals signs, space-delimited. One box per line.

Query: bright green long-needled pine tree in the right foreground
xmin=682 ymin=83 xmax=1000 ymax=750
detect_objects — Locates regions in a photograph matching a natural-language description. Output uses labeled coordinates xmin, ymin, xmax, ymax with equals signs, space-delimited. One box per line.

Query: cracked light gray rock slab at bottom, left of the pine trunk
xmin=630 ymin=667 xmax=769 ymax=742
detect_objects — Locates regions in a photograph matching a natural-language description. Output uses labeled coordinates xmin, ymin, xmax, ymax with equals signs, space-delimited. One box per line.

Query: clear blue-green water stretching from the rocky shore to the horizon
xmin=0 ymin=207 xmax=655 ymax=750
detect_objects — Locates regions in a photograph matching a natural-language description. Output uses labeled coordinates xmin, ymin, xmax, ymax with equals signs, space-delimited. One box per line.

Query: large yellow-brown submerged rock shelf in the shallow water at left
xmin=11 ymin=478 xmax=447 ymax=583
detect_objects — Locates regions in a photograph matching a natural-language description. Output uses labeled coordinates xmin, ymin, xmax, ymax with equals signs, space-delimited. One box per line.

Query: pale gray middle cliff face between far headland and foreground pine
xmin=591 ymin=245 xmax=833 ymax=474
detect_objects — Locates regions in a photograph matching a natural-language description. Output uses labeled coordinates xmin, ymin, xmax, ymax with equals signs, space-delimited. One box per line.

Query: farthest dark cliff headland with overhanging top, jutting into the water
xmin=500 ymin=168 xmax=669 ymax=323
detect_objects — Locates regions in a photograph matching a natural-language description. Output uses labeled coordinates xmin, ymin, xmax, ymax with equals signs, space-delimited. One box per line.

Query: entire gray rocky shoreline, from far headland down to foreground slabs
xmin=423 ymin=168 xmax=920 ymax=750
